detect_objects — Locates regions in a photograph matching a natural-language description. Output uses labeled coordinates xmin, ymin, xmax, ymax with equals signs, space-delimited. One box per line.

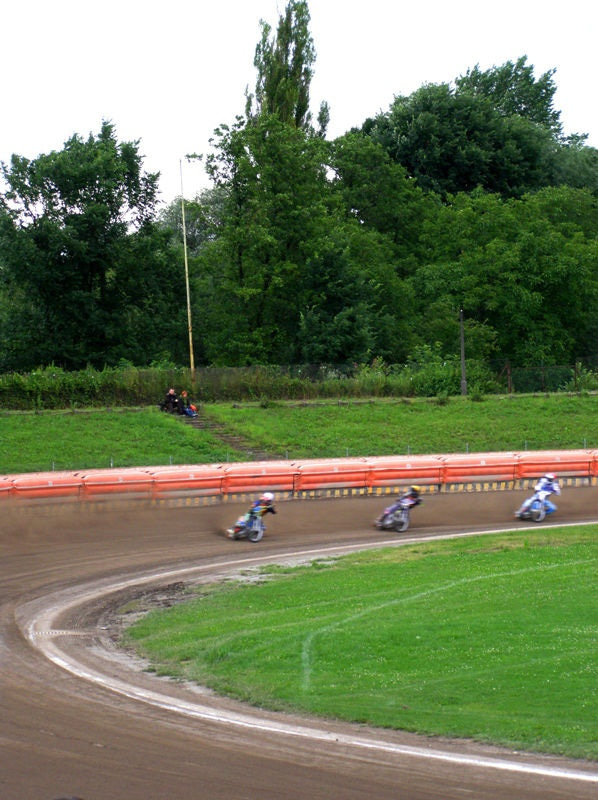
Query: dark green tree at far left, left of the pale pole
xmin=0 ymin=122 xmax=184 ymax=369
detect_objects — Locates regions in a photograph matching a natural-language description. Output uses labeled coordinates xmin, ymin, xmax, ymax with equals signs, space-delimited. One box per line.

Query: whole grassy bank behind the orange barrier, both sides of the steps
xmin=0 ymin=395 xmax=598 ymax=474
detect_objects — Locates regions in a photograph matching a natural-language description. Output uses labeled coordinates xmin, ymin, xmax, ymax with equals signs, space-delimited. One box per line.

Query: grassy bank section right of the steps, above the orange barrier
xmin=206 ymin=395 xmax=598 ymax=458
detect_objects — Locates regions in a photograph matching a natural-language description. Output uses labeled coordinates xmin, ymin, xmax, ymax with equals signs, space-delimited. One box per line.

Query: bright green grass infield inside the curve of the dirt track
xmin=127 ymin=528 xmax=598 ymax=758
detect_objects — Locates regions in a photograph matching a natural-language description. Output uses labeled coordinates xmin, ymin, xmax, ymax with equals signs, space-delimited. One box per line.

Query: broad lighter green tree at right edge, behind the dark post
xmin=413 ymin=187 xmax=598 ymax=366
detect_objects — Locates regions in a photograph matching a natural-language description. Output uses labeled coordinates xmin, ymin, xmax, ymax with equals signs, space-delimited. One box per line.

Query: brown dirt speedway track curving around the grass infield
xmin=0 ymin=487 xmax=598 ymax=800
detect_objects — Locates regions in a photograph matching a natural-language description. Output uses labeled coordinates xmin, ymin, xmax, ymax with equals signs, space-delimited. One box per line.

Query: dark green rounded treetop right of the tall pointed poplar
xmin=363 ymin=84 xmax=555 ymax=198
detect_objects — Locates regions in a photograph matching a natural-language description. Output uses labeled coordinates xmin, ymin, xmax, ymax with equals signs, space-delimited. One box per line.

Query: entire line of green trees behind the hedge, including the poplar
xmin=0 ymin=0 xmax=598 ymax=372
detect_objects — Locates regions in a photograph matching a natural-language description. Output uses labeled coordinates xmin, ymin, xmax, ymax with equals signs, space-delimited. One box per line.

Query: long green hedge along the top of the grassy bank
xmin=0 ymin=356 xmax=598 ymax=411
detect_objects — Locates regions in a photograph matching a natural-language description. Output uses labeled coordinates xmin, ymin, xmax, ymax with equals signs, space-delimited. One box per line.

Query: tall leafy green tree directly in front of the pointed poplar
xmin=202 ymin=114 xmax=338 ymax=363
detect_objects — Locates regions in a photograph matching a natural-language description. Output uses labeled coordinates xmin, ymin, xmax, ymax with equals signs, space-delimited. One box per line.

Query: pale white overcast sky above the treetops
xmin=0 ymin=0 xmax=598 ymax=203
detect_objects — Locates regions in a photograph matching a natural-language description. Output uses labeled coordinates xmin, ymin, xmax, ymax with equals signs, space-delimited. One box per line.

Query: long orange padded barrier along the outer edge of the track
xmin=0 ymin=450 xmax=598 ymax=502
